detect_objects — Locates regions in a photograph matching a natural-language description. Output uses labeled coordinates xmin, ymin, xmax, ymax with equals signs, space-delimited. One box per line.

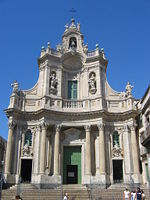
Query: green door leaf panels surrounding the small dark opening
xmin=63 ymin=146 xmax=81 ymax=184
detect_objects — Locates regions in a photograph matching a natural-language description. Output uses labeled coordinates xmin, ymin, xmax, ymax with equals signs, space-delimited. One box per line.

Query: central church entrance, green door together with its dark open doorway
xmin=63 ymin=146 xmax=81 ymax=184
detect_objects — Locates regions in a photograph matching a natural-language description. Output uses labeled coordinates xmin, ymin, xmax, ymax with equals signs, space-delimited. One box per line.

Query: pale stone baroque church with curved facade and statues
xmin=5 ymin=19 xmax=148 ymax=187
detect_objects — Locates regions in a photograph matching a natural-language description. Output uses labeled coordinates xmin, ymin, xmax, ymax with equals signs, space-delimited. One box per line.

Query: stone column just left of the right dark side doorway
xmin=98 ymin=124 xmax=106 ymax=174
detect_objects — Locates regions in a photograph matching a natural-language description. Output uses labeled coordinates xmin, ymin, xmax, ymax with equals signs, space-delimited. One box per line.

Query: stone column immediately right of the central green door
xmin=85 ymin=126 xmax=91 ymax=175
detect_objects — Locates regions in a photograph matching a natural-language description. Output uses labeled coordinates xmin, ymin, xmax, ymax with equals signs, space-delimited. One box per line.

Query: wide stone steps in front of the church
xmin=1 ymin=184 xmax=150 ymax=200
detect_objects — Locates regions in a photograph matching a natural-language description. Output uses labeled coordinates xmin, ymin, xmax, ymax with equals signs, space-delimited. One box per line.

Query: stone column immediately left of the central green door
xmin=54 ymin=125 xmax=61 ymax=175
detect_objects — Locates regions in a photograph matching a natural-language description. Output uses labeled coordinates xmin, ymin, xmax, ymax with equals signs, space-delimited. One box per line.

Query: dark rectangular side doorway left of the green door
xmin=21 ymin=159 xmax=32 ymax=183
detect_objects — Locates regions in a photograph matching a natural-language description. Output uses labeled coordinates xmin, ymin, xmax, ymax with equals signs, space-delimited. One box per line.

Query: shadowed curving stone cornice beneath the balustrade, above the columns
xmin=4 ymin=108 xmax=138 ymax=122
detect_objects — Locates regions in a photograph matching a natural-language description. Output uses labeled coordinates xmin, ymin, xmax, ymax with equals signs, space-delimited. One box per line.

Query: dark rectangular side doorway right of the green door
xmin=113 ymin=160 xmax=123 ymax=183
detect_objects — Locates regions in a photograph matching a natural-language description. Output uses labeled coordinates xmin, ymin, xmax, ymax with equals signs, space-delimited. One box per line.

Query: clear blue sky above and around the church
xmin=0 ymin=0 xmax=150 ymax=139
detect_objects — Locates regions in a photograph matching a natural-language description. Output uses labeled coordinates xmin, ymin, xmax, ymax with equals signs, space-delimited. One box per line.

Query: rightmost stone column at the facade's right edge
xmin=131 ymin=125 xmax=139 ymax=174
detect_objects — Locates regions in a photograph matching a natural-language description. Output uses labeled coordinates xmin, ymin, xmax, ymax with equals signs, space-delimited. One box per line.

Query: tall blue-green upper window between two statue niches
xmin=68 ymin=81 xmax=77 ymax=99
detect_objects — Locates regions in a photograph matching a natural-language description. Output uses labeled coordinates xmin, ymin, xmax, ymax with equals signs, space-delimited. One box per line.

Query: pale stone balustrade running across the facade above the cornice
xmin=22 ymin=96 xmax=136 ymax=113
